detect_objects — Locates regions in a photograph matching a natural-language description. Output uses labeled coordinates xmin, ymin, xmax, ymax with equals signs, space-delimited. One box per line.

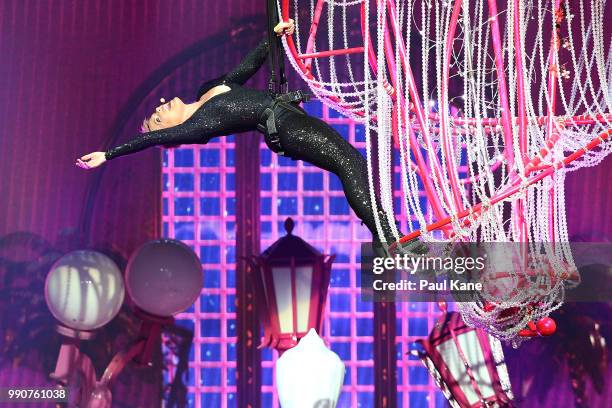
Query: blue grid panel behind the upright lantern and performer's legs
xmin=260 ymin=102 xmax=374 ymax=408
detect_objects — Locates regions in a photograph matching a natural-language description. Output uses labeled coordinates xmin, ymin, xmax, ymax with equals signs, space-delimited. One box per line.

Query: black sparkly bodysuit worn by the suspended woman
xmin=105 ymin=40 xmax=401 ymax=243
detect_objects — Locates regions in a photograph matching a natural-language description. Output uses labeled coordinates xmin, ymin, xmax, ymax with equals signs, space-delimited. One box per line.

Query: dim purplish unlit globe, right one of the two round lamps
xmin=125 ymin=239 xmax=202 ymax=317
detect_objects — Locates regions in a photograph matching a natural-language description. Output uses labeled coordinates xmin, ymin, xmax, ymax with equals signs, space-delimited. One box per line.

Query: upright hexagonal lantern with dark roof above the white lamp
xmin=254 ymin=218 xmax=334 ymax=354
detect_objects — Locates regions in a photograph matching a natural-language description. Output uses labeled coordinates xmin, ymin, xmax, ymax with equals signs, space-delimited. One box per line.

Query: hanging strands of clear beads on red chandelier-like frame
xmin=279 ymin=0 xmax=612 ymax=340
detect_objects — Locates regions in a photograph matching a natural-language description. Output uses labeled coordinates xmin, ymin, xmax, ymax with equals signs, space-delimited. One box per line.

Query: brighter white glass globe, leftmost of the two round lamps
xmin=45 ymin=250 xmax=125 ymax=330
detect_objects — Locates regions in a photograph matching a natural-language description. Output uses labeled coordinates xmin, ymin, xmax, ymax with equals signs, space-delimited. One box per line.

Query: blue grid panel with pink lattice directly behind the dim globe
xmin=162 ymin=136 xmax=236 ymax=408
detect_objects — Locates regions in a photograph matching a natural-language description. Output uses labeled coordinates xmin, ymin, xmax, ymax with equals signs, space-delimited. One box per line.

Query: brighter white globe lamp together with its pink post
xmin=45 ymin=250 xmax=125 ymax=408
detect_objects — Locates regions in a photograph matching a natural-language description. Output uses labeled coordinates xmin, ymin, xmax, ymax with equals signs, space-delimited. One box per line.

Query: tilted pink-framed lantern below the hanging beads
xmin=411 ymin=312 xmax=513 ymax=408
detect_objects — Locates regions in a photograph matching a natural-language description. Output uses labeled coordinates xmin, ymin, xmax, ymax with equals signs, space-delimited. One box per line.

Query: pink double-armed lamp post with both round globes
xmin=45 ymin=239 xmax=202 ymax=408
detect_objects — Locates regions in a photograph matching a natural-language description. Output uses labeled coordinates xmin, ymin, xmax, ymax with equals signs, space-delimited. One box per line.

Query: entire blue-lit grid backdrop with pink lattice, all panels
xmin=162 ymin=102 xmax=446 ymax=408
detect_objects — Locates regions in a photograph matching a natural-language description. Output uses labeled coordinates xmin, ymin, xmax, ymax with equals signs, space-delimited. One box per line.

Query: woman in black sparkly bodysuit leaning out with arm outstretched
xmin=76 ymin=20 xmax=425 ymax=252
